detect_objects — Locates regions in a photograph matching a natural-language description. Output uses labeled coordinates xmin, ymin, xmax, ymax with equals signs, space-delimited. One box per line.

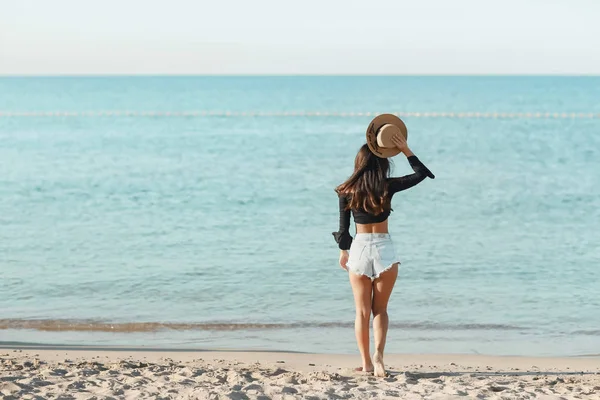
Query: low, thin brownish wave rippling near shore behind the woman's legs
xmin=0 ymin=319 xmax=529 ymax=333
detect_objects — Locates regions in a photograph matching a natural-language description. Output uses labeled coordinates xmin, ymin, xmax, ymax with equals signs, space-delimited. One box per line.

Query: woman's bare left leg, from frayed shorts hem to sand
xmin=348 ymin=272 xmax=373 ymax=372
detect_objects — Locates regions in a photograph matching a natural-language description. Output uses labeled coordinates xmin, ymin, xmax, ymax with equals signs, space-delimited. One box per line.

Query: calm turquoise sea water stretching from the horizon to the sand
xmin=0 ymin=77 xmax=600 ymax=355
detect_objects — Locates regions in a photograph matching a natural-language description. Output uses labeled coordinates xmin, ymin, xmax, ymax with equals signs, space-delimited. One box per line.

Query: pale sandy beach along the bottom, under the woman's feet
xmin=0 ymin=346 xmax=600 ymax=400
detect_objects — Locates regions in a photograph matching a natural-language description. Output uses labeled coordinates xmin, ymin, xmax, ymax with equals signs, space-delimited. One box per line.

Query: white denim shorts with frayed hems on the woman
xmin=346 ymin=233 xmax=400 ymax=280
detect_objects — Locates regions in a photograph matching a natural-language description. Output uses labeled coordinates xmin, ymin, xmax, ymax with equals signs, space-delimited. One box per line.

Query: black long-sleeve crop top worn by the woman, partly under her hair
xmin=332 ymin=155 xmax=435 ymax=250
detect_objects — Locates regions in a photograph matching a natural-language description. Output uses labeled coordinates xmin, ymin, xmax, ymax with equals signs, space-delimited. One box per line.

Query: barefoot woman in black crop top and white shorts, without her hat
xmin=333 ymin=133 xmax=435 ymax=377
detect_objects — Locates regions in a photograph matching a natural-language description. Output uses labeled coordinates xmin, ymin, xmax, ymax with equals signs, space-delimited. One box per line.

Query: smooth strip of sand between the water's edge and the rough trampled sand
xmin=0 ymin=344 xmax=600 ymax=374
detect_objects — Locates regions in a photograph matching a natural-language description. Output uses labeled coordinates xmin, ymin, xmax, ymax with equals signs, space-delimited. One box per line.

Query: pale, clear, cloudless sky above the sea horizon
xmin=0 ymin=0 xmax=600 ymax=75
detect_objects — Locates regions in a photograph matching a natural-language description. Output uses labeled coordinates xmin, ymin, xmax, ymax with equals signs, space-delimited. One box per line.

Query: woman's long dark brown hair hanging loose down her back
xmin=335 ymin=143 xmax=390 ymax=215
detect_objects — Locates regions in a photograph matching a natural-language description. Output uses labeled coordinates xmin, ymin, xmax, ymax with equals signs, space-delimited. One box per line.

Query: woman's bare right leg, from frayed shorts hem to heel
xmin=373 ymin=264 xmax=398 ymax=377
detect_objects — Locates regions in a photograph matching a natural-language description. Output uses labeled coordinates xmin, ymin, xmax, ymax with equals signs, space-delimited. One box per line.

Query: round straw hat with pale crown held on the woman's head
xmin=367 ymin=114 xmax=408 ymax=158
